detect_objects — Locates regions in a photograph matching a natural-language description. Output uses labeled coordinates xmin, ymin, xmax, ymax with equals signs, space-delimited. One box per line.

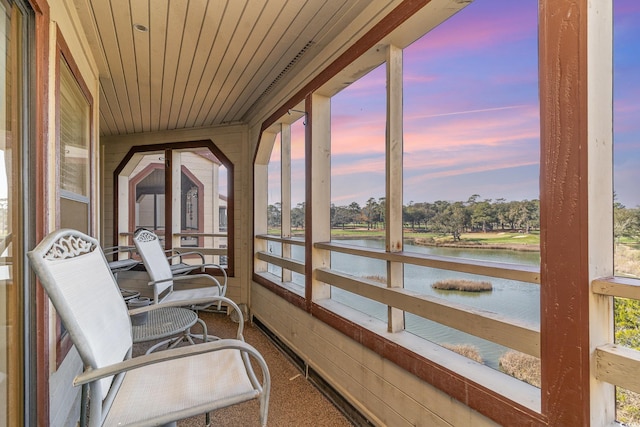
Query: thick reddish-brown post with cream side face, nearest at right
xmin=539 ymin=0 xmax=615 ymax=426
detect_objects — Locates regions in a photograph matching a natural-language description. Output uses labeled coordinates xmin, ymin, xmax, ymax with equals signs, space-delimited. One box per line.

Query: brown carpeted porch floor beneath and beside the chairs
xmin=134 ymin=312 xmax=352 ymax=427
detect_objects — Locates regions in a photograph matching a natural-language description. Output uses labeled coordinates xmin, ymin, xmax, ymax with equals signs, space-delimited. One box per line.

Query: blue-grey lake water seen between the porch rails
xmin=269 ymin=239 xmax=540 ymax=369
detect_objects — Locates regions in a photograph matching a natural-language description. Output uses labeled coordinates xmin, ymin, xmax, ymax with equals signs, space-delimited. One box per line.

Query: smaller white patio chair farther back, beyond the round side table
xmin=133 ymin=228 xmax=227 ymax=309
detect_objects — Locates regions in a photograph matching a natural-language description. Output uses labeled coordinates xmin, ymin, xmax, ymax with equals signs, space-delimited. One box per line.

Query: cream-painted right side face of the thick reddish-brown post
xmin=582 ymin=0 xmax=616 ymax=426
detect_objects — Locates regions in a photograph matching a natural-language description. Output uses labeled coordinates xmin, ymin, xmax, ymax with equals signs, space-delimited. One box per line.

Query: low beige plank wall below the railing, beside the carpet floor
xmin=251 ymin=283 xmax=496 ymax=427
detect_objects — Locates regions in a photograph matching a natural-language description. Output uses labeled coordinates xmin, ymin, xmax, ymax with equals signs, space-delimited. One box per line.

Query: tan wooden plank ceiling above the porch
xmin=74 ymin=0 xmax=369 ymax=136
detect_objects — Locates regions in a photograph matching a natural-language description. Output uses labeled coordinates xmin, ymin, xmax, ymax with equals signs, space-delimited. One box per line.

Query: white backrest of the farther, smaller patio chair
xmin=133 ymin=228 xmax=173 ymax=296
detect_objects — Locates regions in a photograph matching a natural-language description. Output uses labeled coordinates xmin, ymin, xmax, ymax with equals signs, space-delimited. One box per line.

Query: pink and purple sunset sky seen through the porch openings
xmin=270 ymin=0 xmax=640 ymax=211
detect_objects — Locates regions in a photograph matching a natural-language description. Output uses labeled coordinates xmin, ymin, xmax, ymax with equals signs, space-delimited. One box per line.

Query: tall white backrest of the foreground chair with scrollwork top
xmin=28 ymin=229 xmax=133 ymax=399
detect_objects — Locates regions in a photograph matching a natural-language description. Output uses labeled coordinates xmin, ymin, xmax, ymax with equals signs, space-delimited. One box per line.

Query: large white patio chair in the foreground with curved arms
xmin=28 ymin=229 xmax=270 ymax=426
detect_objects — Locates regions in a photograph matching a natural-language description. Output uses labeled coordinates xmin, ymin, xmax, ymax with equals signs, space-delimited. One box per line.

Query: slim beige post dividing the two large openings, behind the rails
xmin=385 ymin=45 xmax=404 ymax=332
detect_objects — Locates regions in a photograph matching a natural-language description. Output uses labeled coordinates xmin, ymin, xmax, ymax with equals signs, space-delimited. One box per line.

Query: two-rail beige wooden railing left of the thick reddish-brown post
xmin=256 ymin=235 xmax=540 ymax=357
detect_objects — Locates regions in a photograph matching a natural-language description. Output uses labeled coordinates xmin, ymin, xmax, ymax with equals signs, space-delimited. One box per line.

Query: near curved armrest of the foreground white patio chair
xmin=73 ymin=339 xmax=270 ymax=387
